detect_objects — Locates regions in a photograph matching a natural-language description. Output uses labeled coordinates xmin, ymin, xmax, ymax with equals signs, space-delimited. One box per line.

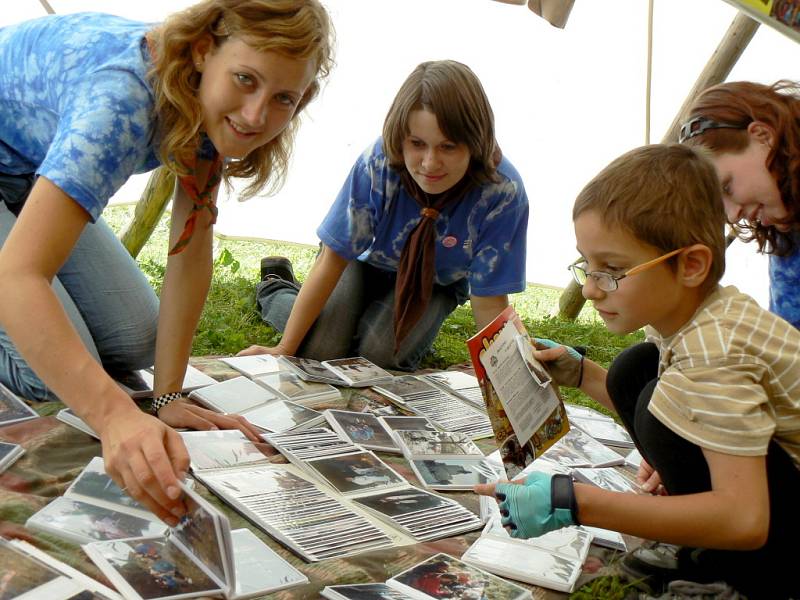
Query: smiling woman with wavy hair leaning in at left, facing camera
xmin=0 ymin=0 xmax=332 ymax=524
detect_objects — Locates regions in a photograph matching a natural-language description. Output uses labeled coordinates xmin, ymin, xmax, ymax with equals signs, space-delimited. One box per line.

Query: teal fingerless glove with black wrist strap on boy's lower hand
xmin=495 ymin=472 xmax=578 ymax=538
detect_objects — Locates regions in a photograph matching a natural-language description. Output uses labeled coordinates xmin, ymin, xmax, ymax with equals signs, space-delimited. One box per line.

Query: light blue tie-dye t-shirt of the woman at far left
xmin=0 ymin=13 xmax=159 ymax=221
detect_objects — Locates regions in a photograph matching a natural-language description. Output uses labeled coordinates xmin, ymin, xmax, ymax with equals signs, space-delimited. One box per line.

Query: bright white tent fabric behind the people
xmin=0 ymin=0 xmax=797 ymax=305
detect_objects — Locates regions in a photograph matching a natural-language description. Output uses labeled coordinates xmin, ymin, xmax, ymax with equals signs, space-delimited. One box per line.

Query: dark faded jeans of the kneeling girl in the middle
xmin=256 ymin=260 xmax=467 ymax=371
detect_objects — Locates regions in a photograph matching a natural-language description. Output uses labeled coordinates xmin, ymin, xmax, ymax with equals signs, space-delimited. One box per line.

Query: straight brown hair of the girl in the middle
xmin=383 ymin=60 xmax=500 ymax=184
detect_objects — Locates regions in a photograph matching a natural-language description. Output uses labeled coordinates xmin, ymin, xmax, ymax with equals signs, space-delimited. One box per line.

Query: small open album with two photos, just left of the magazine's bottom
xmin=393 ymin=431 xmax=496 ymax=490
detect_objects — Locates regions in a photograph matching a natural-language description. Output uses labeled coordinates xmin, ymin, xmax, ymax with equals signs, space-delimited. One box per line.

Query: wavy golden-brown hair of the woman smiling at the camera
xmin=148 ymin=0 xmax=333 ymax=198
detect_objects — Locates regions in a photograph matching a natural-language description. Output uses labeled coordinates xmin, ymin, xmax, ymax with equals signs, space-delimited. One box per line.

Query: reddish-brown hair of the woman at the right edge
xmin=685 ymin=80 xmax=800 ymax=255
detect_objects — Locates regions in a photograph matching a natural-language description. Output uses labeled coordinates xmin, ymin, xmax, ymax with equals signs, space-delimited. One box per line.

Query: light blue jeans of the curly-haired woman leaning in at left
xmin=0 ymin=174 xmax=158 ymax=400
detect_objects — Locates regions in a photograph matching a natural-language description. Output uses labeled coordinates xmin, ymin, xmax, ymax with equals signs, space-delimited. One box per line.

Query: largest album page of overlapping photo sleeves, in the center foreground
xmin=196 ymin=464 xmax=394 ymax=562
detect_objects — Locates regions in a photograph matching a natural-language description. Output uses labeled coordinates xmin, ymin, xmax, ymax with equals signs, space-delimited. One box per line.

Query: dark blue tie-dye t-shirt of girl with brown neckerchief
xmin=317 ymin=139 xmax=528 ymax=296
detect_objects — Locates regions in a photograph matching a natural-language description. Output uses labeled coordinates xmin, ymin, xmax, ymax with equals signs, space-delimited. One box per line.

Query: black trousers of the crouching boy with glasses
xmin=606 ymin=342 xmax=800 ymax=599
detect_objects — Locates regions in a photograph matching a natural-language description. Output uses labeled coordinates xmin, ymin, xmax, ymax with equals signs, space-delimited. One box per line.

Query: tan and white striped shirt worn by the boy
xmin=648 ymin=286 xmax=800 ymax=468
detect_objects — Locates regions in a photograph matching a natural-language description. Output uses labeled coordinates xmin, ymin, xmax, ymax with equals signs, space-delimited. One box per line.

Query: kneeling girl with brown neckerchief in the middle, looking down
xmin=243 ymin=60 xmax=528 ymax=371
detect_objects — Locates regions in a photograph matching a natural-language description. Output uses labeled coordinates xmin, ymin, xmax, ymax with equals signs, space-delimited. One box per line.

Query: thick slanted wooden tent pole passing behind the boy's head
xmin=558 ymin=12 xmax=759 ymax=320
